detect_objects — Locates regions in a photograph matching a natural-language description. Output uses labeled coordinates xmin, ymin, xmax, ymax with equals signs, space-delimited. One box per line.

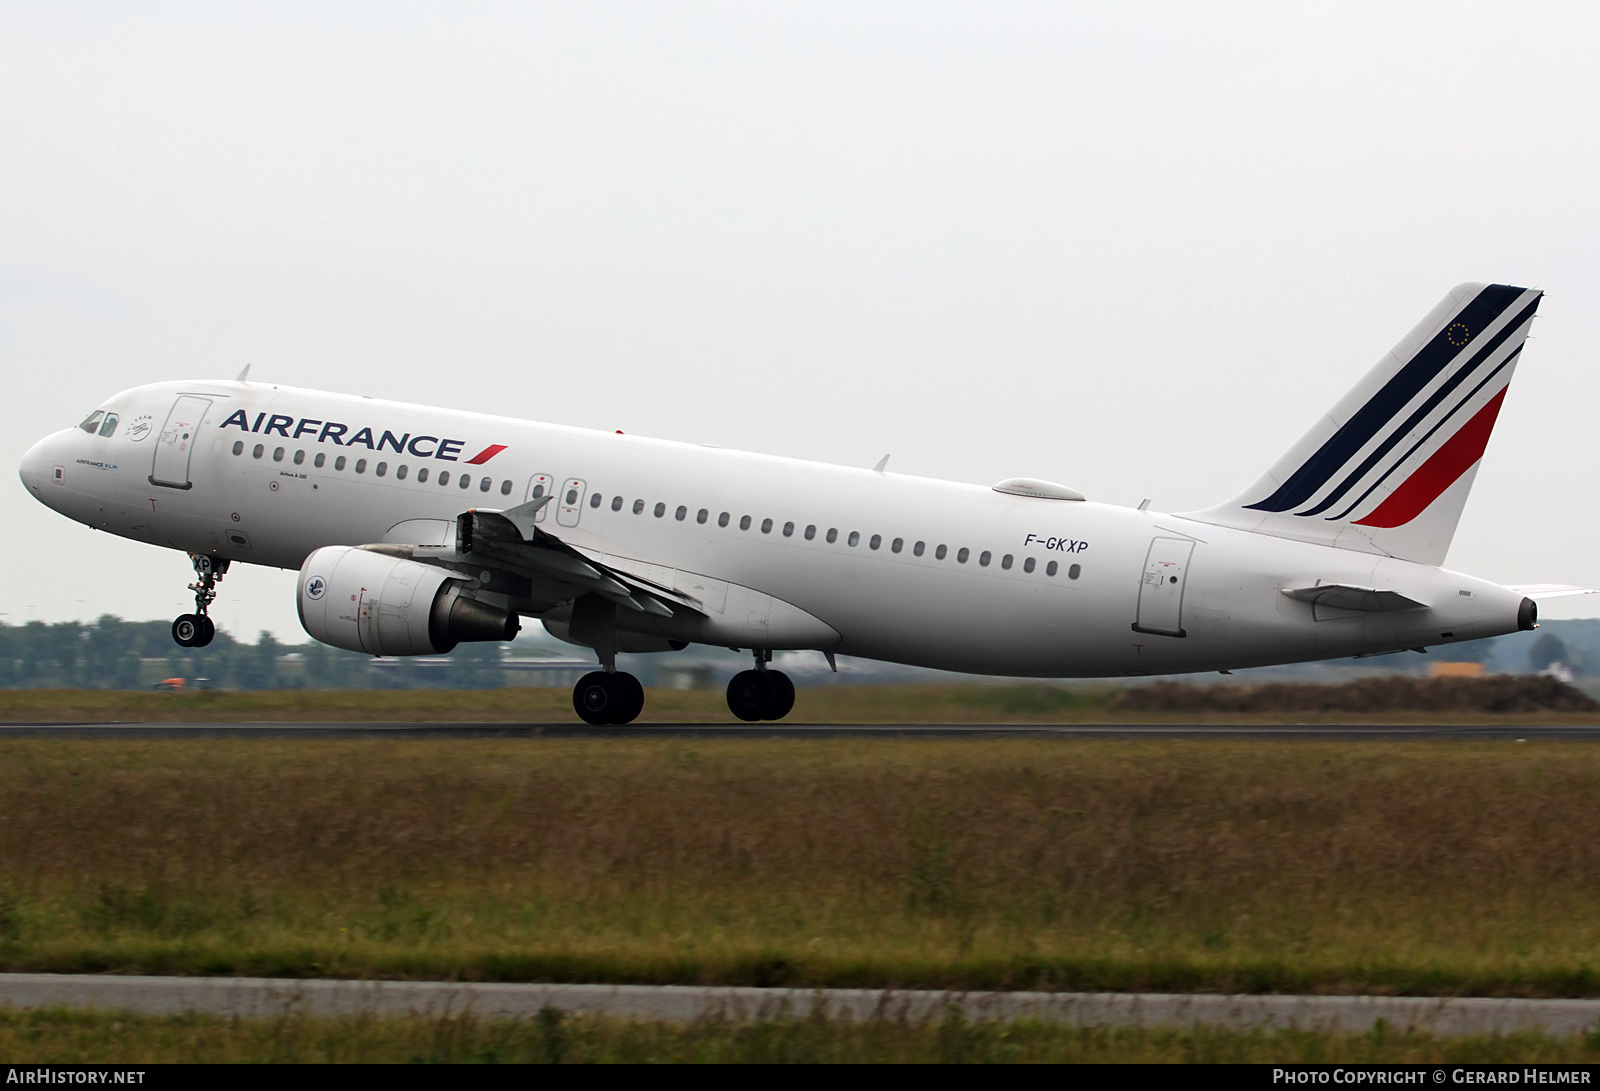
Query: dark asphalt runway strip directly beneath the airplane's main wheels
xmin=0 ymin=721 xmax=1600 ymax=742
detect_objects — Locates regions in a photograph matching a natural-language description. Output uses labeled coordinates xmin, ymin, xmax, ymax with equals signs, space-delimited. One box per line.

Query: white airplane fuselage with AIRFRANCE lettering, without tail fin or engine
xmin=22 ymin=381 xmax=1520 ymax=677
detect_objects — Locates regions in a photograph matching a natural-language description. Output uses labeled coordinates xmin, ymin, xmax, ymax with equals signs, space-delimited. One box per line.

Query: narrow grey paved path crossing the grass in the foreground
xmin=0 ymin=974 xmax=1600 ymax=1037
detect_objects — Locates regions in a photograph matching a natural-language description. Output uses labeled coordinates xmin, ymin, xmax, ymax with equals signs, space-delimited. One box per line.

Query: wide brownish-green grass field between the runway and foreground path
xmin=0 ymin=739 xmax=1600 ymax=995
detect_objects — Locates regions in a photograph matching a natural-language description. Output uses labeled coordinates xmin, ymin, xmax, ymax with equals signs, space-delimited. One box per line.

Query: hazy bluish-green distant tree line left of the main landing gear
xmin=0 ymin=614 xmax=504 ymax=689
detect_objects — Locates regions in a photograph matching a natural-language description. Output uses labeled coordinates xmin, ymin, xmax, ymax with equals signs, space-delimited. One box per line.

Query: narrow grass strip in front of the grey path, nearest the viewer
xmin=0 ymin=1009 xmax=1600 ymax=1065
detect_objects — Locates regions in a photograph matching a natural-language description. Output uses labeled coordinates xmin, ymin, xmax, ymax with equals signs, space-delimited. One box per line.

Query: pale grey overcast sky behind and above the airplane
xmin=0 ymin=0 xmax=1600 ymax=640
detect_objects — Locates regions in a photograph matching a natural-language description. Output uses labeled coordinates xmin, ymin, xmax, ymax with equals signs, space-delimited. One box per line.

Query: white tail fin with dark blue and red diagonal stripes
xmin=1186 ymin=285 xmax=1542 ymax=565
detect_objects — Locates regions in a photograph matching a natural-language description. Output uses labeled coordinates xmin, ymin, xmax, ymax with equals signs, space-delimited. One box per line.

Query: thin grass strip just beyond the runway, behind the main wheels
xmin=0 ymin=680 xmax=1597 ymax=725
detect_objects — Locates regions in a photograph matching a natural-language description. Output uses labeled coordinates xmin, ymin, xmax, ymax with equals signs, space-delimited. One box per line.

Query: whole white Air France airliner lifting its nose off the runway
xmin=21 ymin=285 xmax=1576 ymax=725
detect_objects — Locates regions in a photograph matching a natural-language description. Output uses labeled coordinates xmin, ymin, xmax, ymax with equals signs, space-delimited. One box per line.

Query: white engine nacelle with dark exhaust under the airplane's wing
xmin=296 ymin=546 xmax=520 ymax=656
